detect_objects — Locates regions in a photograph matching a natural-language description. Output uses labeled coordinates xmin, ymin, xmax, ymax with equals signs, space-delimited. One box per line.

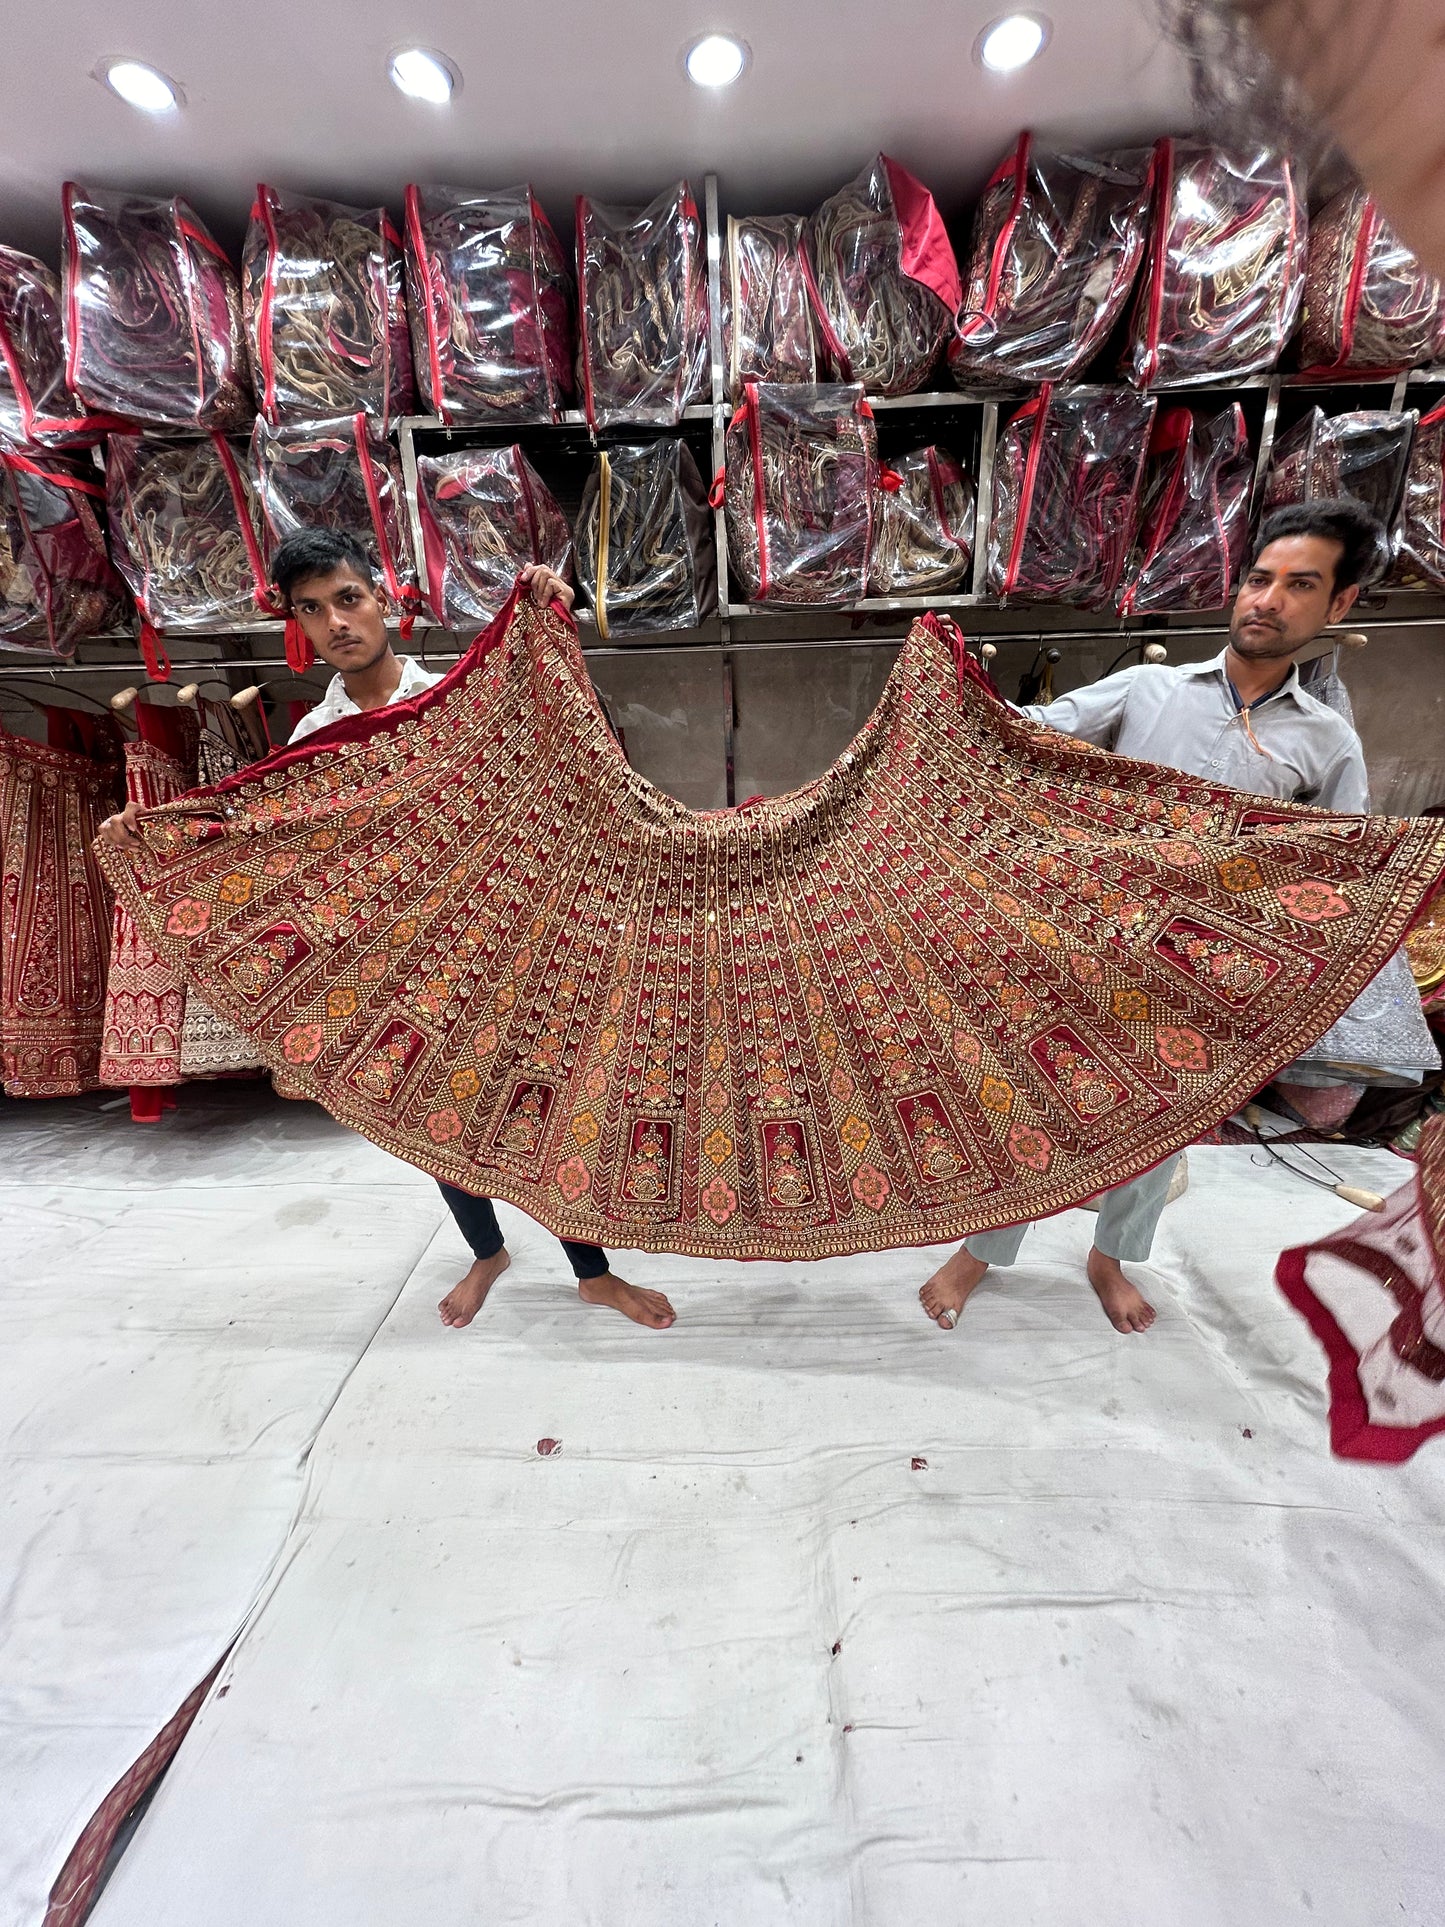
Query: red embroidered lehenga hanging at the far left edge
xmin=0 ymin=709 xmax=119 ymax=1096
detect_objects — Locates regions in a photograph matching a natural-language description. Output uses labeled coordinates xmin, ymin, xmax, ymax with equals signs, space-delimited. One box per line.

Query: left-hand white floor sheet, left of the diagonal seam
xmin=0 ymin=1089 xmax=443 ymax=1927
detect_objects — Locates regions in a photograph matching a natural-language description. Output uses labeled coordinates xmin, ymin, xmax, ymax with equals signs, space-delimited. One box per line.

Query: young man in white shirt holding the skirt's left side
xmin=100 ymin=528 xmax=676 ymax=1332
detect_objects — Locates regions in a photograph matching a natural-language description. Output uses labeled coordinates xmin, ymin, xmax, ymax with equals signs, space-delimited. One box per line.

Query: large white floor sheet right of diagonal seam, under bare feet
xmin=62 ymin=1147 xmax=1445 ymax=1927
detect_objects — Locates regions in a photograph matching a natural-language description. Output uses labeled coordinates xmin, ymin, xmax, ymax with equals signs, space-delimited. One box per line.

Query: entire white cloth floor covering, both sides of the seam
xmin=0 ymin=1093 xmax=1445 ymax=1927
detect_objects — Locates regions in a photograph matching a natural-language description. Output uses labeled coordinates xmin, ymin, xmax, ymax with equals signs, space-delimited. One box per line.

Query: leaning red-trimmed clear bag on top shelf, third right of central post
xmin=948 ymin=133 xmax=1152 ymax=387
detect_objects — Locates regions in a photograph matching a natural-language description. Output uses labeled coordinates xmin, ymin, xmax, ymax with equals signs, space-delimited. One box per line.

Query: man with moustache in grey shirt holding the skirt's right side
xmin=919 ymin=501 xmax=1385 ymax=1332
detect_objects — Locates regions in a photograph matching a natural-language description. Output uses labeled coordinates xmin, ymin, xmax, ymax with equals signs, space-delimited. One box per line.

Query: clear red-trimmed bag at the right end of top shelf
xmin=1299 ymin=187 xmax=1445 ymax=372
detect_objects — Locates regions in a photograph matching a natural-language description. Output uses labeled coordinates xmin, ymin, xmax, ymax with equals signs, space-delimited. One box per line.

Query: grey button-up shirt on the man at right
xmin=1019 ymin=649 xmax=1370 ymax=815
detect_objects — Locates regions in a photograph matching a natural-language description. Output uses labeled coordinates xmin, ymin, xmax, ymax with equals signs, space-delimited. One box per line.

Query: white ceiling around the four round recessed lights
xmin=0 ymin=0 xmax=1189 ymax=260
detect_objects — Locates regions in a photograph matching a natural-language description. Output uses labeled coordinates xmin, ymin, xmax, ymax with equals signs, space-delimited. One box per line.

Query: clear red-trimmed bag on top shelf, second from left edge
xmin=64 ymin=181 xmax=254 ymax=432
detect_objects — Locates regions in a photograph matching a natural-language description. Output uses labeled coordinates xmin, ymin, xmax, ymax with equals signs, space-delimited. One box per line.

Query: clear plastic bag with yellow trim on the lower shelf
xmin=576 ymin=439 xmax=717 ymax=642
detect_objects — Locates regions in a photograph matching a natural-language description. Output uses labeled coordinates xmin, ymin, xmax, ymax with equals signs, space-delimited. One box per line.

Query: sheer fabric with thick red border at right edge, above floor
xmin=1275 ymin=1118 xmax=1445 ymax=1461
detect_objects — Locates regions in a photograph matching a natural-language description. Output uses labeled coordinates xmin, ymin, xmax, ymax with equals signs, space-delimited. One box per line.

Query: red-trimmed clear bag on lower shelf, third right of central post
xmin=988 ymin=382 xmax=1156 ymax=609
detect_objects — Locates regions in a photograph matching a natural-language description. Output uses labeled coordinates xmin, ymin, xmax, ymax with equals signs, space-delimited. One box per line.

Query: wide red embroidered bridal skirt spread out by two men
xmin=102 ymin=599 xmax=1445 ymax=1258
